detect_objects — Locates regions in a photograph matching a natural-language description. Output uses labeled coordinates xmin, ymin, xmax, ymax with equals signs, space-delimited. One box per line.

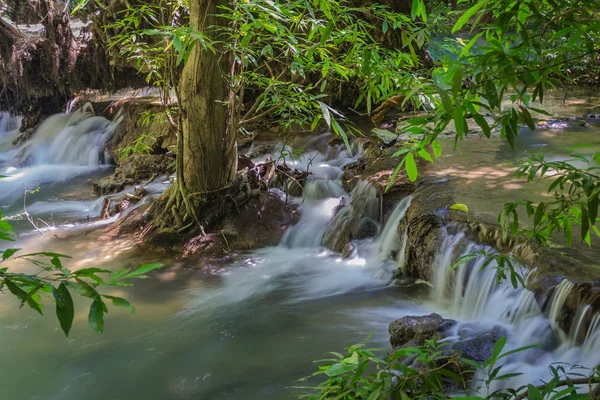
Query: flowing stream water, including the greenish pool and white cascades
xmin=0 ymin=94 xmax=600 ymax=400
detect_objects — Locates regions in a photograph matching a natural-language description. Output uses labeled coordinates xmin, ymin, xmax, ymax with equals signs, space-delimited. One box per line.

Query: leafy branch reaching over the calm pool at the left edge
xmin=0 ymin=211 xmax=162 ymax=336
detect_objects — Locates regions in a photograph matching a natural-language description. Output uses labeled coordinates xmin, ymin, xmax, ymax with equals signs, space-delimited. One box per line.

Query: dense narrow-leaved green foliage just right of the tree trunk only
xmin=220 ymin=0 xmax=427 ymax=145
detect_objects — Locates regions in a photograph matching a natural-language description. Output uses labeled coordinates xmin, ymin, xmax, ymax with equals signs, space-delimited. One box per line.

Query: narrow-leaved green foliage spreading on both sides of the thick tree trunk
xmin=81 ymin=0 xmax=429 ymax=152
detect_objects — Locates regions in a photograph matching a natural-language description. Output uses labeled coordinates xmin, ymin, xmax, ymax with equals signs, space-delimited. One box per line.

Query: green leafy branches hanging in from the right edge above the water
xmin=395 ymin=0 xmax=600 ymax=250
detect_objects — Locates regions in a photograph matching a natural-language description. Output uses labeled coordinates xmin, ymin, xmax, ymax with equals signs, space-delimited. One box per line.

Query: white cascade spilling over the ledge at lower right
xmin=432 ymin=228 xmax=600 ymax=390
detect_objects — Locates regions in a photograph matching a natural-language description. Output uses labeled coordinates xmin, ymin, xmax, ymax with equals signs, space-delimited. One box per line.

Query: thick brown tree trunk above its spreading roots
xmin=177 ymin=0 xmax=237 ymax=197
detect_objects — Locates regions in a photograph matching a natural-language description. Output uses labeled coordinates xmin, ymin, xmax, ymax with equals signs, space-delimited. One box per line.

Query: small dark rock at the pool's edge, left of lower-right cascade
xmin=389 ymin=313 xmax=456 ymax=348
